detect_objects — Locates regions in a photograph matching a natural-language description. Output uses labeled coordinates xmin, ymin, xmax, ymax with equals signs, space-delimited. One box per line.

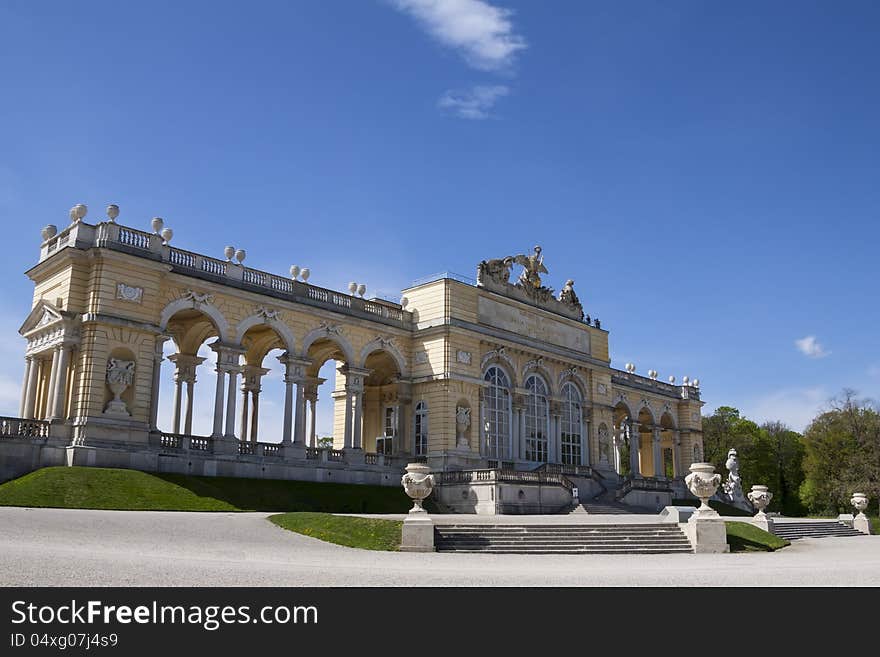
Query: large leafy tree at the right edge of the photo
xmin=800 ymin=389 xmax=880 ymax=513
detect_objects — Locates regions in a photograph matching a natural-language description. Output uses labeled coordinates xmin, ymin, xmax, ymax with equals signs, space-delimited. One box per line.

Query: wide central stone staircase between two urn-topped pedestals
xmin=434 ymin=523 xmax=693 ymax=554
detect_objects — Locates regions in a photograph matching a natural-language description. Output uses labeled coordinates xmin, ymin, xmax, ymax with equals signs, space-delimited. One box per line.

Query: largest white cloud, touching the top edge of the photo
xmin=391 ymin=0 xmax=527 ymax=71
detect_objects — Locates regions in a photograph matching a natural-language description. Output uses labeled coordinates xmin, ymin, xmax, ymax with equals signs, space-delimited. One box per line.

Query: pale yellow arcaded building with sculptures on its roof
xmin=0 ymin=206 xmax=702 ymax=513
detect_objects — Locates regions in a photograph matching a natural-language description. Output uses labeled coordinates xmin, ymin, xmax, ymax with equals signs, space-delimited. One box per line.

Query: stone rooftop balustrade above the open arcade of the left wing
xmin=40 ymin=222 xmax=412 ymax=328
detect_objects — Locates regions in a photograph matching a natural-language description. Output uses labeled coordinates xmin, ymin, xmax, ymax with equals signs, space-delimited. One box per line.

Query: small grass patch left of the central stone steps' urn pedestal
xmin=269 ymin=513 xmax=403 ymax=550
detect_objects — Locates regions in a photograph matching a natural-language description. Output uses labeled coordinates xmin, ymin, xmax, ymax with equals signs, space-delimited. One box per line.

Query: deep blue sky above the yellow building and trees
xmin=0 ymin=0 xmax=880 ymax=436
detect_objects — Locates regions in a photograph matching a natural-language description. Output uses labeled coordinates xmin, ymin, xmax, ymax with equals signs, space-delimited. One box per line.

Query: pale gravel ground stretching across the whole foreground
xmin=0 ymin=507 xmax=880 ymax=586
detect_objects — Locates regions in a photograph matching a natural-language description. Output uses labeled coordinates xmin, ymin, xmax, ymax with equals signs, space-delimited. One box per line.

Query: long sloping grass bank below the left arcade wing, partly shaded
xmin=0 ymin=467 xmax=412 ymax=513
